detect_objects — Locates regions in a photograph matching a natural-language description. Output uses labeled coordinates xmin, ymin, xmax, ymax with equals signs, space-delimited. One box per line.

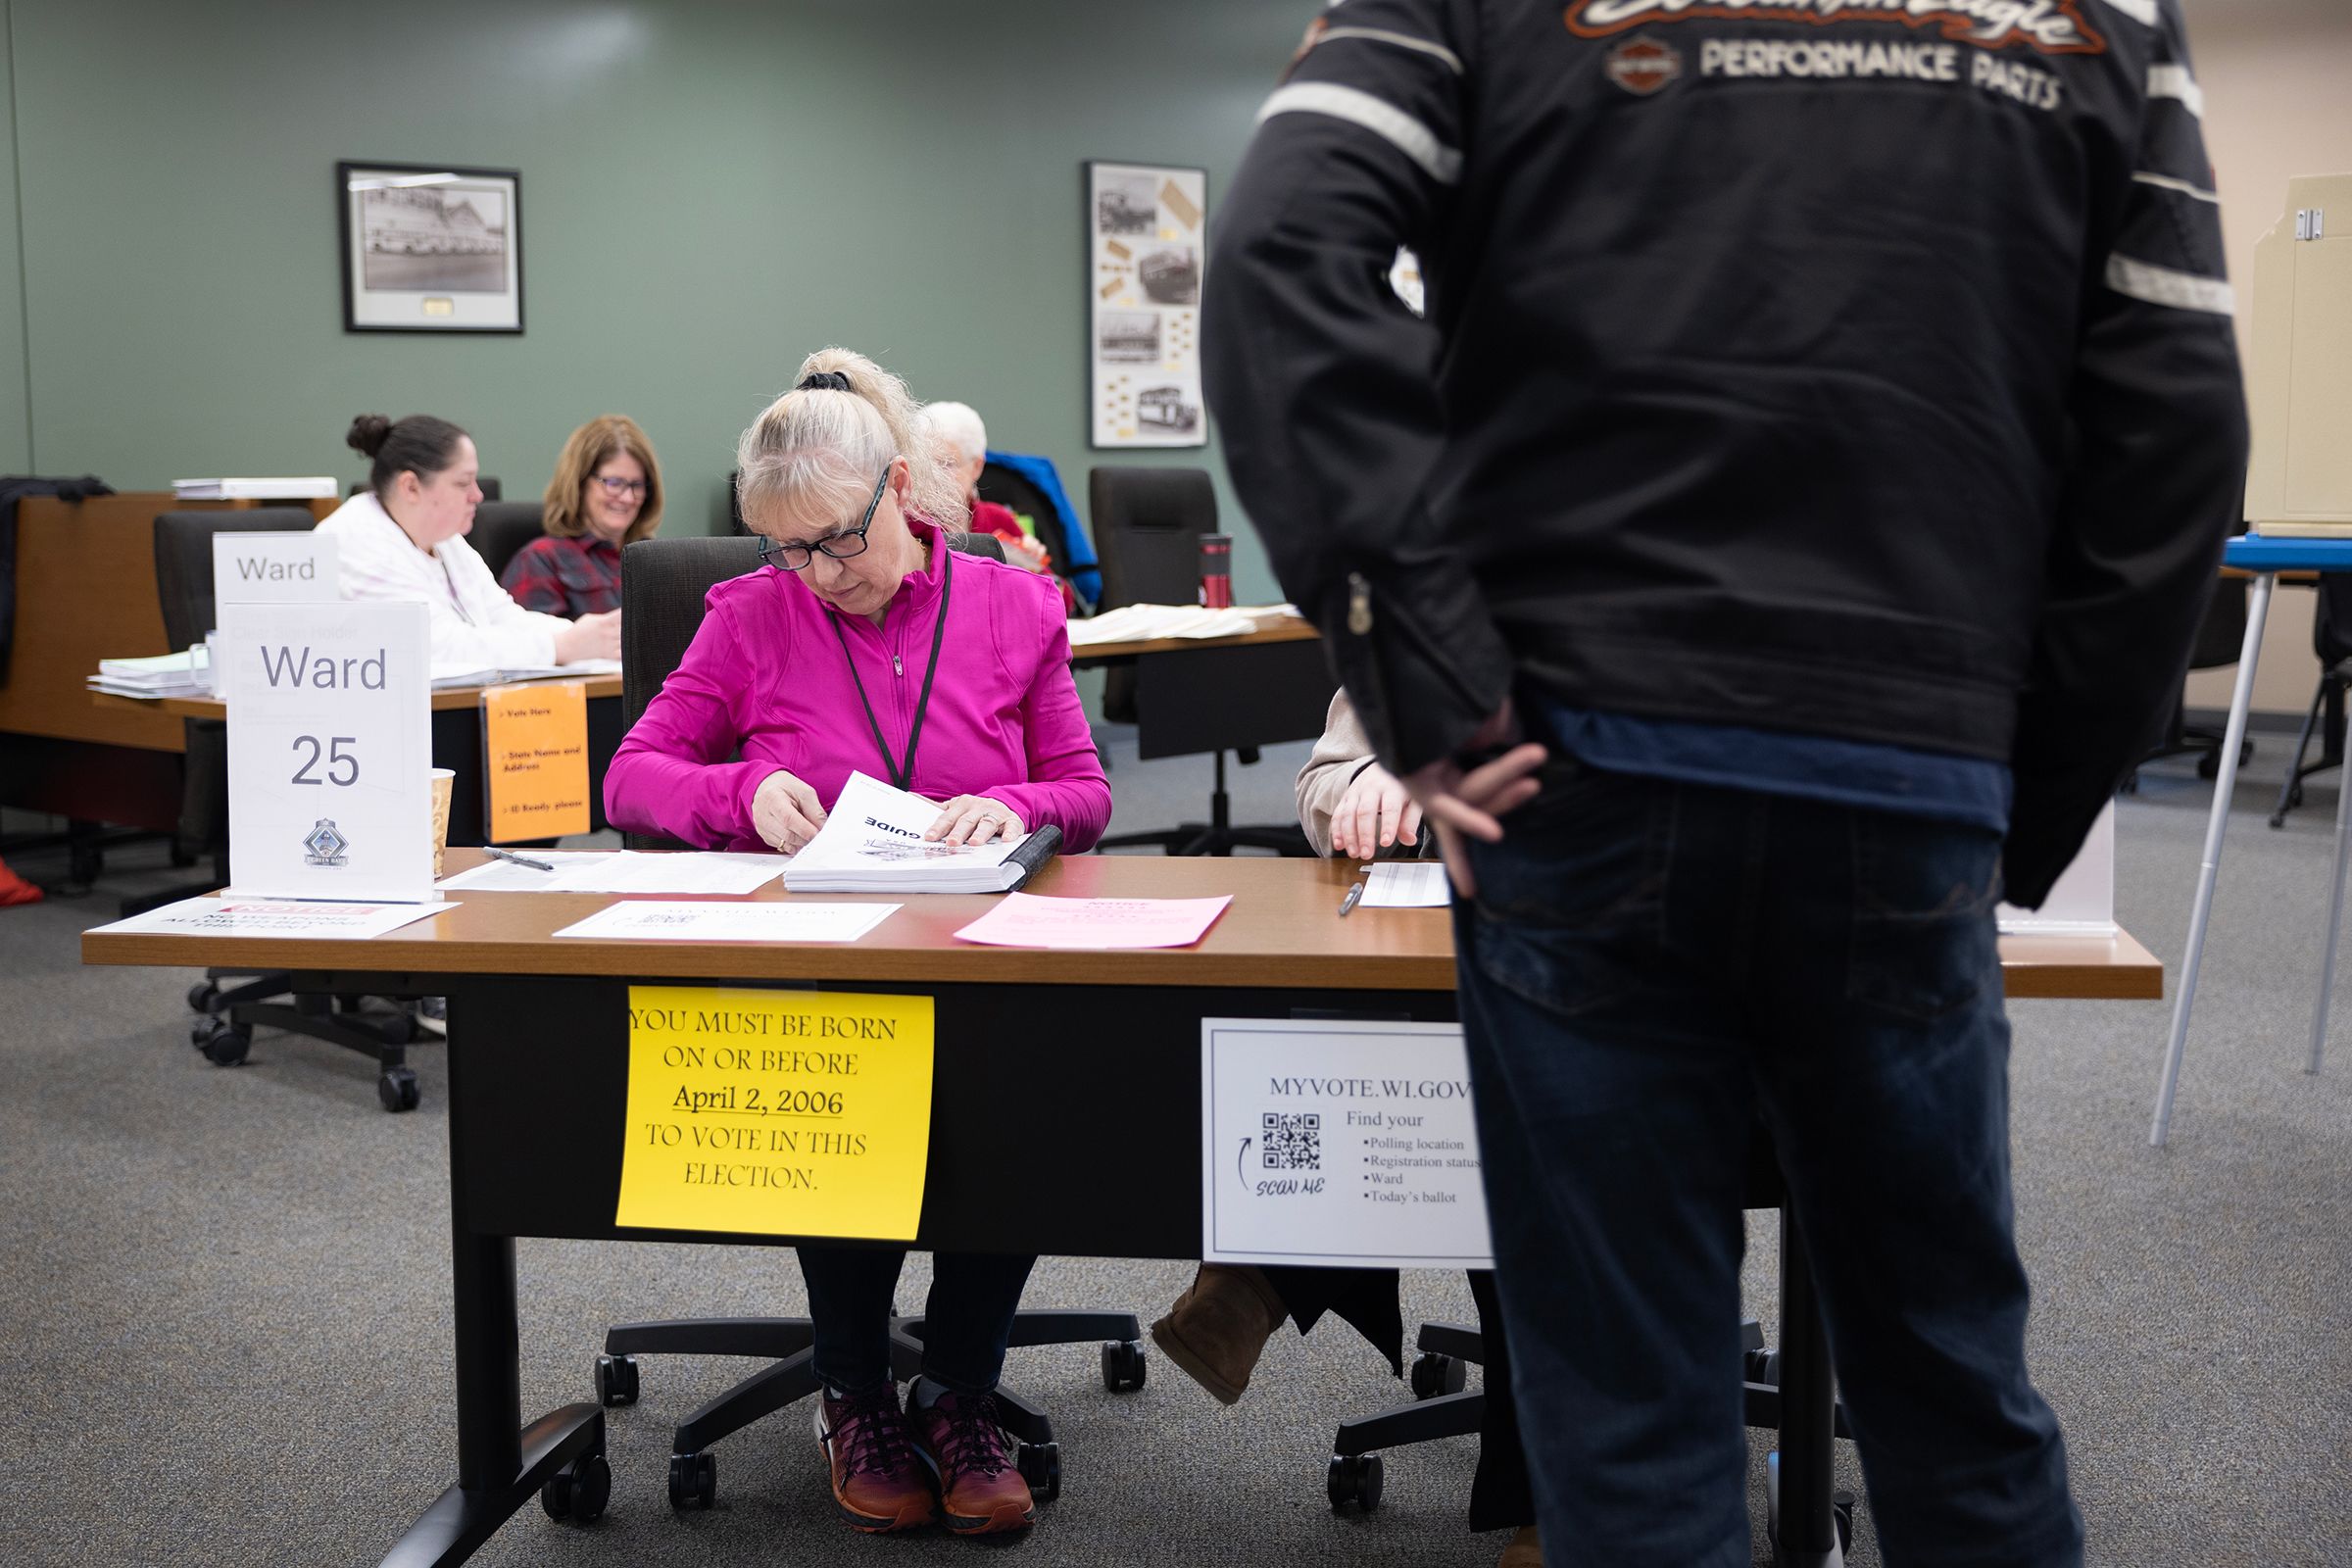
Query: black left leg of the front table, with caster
xmin=383 ymin=992 xmax=612 ymax=1568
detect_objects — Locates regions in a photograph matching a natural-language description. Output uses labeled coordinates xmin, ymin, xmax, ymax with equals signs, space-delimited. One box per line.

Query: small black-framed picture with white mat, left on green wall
xmin=334 ymin=163 xmax=522 ymax=331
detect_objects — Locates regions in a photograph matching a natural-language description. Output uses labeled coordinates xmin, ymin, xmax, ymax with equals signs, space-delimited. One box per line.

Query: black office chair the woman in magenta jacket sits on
xmin=595 ymin=536 xmax=1143 ymax=1509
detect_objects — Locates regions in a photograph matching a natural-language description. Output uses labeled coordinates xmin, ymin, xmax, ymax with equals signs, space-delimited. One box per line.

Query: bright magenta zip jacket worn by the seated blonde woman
xmin=605 ymin=517 xmax=1110 ymax=854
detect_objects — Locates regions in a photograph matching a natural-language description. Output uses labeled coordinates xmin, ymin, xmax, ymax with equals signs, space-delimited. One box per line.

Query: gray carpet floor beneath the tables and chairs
xmin=0 ymin=738 xmax=2352 ymax=1568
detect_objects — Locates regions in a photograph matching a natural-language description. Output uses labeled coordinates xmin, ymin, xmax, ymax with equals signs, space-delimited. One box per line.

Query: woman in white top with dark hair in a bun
xmin=318 ymin=414 xmax=621 ymax=670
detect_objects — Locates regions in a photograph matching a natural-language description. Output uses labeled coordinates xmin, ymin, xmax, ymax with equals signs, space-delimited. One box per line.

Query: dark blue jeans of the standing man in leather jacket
xmin=1453 ymin=760 xmax=2082 ymax=1568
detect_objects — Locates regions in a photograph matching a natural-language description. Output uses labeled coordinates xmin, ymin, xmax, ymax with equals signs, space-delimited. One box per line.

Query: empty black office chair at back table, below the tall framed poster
xmin=1087 ymin=467 xmax=1331 ymax=856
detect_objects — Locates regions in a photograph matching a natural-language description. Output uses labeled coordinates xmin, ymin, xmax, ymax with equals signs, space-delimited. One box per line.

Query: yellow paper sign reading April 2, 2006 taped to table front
xmin=613 ymin=985 xmax=931 ymax=1242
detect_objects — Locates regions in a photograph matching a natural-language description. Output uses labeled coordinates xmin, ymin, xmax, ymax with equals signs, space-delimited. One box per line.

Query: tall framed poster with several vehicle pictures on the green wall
xmin=1087 ymin=163 xmax=1209 ymax=447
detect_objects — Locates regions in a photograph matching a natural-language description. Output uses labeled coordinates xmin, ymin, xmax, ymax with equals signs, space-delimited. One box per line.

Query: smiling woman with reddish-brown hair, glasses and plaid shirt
xmin=499 ymin=414 xmax=661 ymax=615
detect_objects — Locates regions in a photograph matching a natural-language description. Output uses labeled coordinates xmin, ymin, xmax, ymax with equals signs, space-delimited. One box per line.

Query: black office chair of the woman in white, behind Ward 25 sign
xmin=151 ymin=508 xmax=437 ymax=1112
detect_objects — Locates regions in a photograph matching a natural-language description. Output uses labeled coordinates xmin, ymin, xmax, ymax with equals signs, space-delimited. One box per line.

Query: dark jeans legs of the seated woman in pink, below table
xmin=800 ymin=1246 xmax=1037 ymax=1394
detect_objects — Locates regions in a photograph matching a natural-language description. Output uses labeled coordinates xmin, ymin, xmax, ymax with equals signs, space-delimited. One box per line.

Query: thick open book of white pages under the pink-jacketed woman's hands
xmin=783 ymin=773 xmax=1060 ymax=894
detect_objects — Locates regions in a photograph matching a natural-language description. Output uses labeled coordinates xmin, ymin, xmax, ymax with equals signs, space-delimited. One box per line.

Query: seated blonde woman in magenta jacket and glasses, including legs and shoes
xmin=605 ymin=348 xmax=1110 ymax=1535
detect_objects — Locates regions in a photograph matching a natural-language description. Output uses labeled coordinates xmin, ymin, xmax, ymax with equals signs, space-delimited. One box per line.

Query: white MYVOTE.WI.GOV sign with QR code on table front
xmin=1200 ymin=1018 xmax=1494 ymax=1269
